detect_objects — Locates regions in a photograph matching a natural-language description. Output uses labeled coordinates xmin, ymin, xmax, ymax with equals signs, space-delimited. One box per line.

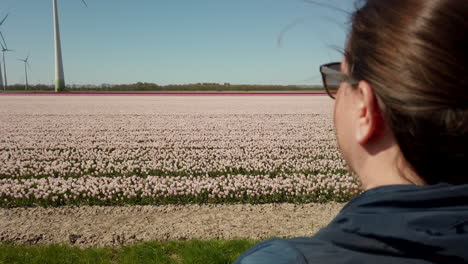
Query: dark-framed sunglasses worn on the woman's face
xmin=320 ymin=62 xmax=359 ymax=99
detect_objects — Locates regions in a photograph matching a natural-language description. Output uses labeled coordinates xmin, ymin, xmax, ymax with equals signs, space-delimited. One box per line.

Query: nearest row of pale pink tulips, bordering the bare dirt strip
xmin=0 ymin=174 xmax=359 ymax=207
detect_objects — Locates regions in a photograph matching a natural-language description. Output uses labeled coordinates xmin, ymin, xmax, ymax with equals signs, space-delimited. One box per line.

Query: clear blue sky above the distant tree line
xmin=0 ymin=0 xmax=354 ymax=85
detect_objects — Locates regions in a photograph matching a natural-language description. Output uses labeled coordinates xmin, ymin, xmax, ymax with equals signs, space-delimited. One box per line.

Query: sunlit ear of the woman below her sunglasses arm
xmin=355 ymin=81 xmax=381 ymax=145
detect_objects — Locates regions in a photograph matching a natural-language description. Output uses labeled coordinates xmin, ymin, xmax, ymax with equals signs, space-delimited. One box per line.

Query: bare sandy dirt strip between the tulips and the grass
xmin=0 ymin=203 xmax=344 ymax=247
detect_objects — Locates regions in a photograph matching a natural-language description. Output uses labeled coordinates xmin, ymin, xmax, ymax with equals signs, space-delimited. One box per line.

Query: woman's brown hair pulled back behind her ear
xmin=345 ymin=0 xmax=468 ymax=184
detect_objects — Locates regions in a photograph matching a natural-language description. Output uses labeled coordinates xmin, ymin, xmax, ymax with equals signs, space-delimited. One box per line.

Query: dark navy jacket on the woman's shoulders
xmin=235 ymin=184 xmax=468 ymax=264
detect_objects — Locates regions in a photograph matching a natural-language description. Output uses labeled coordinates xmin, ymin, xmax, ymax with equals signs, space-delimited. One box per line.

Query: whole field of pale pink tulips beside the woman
xmin=0 ymin=96 xmax=358 ymax=207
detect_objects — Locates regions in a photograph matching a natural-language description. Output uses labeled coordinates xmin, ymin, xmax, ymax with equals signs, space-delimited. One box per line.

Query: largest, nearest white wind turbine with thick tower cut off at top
xmin=52 ymin=0 xmax=88 ymax=92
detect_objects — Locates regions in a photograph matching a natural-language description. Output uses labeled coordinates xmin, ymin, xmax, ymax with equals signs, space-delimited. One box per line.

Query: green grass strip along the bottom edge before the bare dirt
xmin=0 ymin=240 xmax=258 ymax=264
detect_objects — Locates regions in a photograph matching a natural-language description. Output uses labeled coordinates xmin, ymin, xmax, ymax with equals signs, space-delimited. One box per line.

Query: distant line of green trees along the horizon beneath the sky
xmin=1 ymin=82 xmax=323 ymax=92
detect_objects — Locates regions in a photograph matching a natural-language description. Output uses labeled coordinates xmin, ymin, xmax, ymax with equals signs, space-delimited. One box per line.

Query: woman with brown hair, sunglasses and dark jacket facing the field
xmin=235 ymin=0 xmax=468 ymax=264
